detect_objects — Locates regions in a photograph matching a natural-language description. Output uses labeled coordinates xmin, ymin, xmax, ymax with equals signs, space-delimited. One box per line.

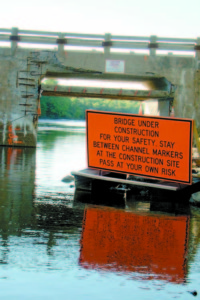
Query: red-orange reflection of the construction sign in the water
xmin=80 ymin=208 xmax=190 ymax=283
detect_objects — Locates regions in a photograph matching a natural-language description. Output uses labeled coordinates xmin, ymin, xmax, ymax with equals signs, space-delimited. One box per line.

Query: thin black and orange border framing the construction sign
xmin=86 ymin=110 xmax=194 ymax=185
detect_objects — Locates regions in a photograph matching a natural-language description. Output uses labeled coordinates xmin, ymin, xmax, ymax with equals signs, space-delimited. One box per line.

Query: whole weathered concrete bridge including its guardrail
xmin=0 ymin=28 xmax=200 ymax=147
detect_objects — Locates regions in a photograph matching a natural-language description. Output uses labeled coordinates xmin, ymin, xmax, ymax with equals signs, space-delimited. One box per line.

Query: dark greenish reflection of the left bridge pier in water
xmin=0 ymin=147 xmax=36 ymax=240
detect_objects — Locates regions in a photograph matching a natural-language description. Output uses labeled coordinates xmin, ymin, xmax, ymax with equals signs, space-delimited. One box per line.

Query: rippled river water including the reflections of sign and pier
xmin=0 ymin=121 xmax=200 ymax=300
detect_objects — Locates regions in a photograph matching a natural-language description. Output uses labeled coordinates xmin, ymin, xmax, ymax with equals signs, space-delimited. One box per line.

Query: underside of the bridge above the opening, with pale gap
xmin=41 ymin=72 xmax=174 ymax=101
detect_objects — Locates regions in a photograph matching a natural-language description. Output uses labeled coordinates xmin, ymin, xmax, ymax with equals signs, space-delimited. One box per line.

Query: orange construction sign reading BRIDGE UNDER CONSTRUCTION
xmin=86 ymin=110 xmax=193 ymax=184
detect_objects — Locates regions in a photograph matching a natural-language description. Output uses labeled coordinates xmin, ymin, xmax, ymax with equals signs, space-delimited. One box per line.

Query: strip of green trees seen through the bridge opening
xmin=41 ymin=96 xmax=140 ymax=120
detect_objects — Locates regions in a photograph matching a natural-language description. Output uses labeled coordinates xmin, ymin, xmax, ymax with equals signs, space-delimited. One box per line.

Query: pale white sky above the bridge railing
xmin=0 ymin=0 xmax=200 ymax=38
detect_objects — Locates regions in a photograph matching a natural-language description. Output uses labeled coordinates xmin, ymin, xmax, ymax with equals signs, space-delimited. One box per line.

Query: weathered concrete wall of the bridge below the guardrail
xmin=0 ymin=48 xmax=200 ymax=147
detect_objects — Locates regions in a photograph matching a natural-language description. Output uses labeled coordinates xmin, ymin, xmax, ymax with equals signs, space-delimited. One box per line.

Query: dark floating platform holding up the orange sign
xmin=71 ymin=168 xmax=200 ymax=202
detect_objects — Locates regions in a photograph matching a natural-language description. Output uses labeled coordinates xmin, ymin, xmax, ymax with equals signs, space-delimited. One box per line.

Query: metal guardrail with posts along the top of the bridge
xmin=0 ymin=28 xmax=200 ymax=54
